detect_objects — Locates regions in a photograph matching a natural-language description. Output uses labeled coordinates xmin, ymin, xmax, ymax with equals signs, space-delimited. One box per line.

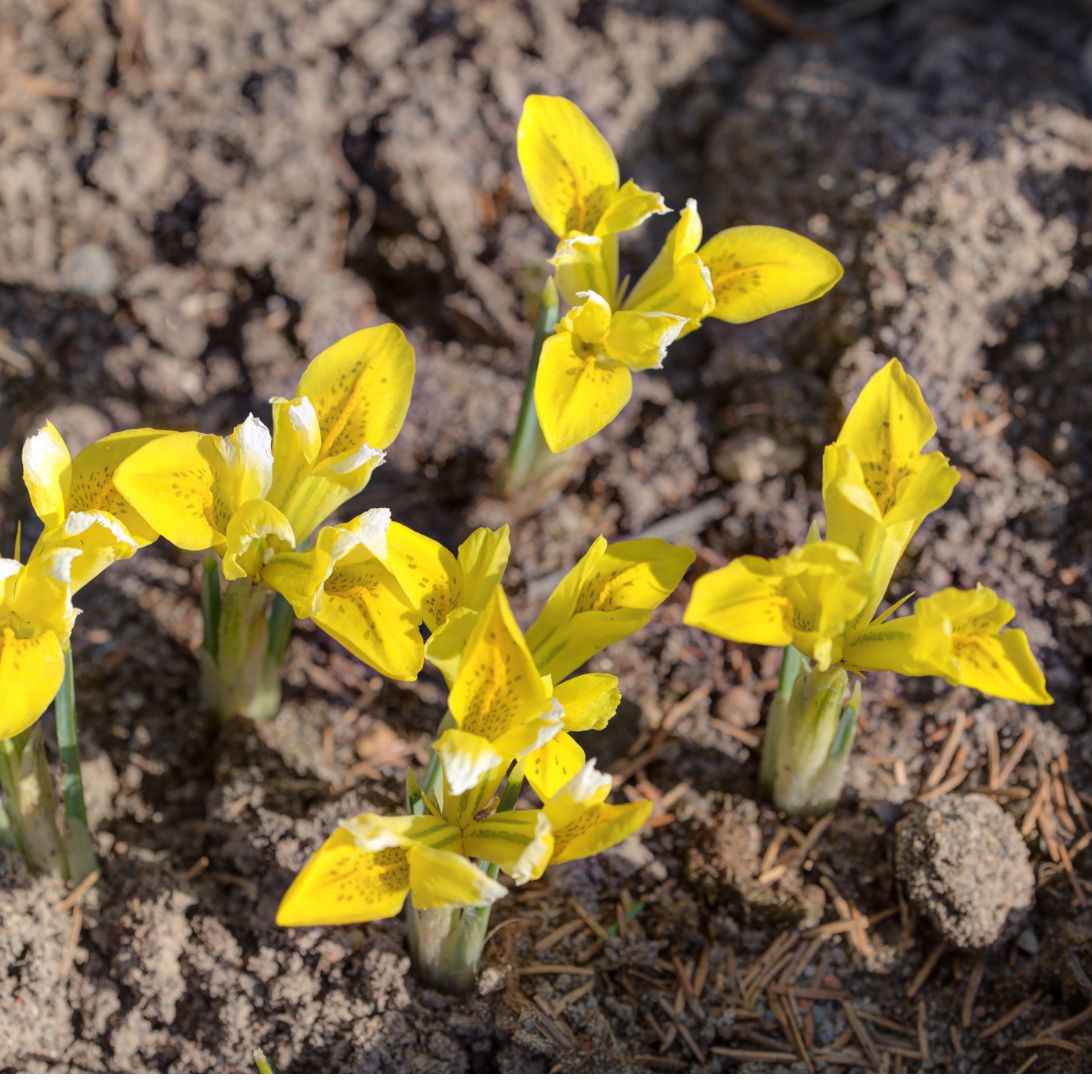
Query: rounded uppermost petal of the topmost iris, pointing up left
xmin=517 ymin=94 xmax=618 ymax=237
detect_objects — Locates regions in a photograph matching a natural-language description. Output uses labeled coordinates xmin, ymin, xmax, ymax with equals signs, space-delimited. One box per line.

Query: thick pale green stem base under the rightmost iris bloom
xmin=761 ymin=645 xmax=860 ymax=816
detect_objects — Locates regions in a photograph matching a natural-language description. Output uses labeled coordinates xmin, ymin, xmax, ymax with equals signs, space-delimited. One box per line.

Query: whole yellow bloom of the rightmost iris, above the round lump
xmin=684 ymin=360 xmax=1052 ymax=704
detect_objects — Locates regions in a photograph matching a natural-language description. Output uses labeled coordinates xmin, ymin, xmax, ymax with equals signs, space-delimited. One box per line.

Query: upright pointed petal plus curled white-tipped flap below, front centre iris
xmin=434 ymin=585 xmax=562 ymax=795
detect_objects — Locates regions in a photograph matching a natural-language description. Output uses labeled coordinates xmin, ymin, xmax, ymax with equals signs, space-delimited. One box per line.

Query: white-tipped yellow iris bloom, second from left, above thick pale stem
xmin=115 ymin=325 xmax=429 ymax=679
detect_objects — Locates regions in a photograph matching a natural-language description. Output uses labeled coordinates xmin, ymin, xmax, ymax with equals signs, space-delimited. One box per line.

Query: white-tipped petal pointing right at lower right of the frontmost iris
xmin=543 ymin=759 xmax=652 ymax=865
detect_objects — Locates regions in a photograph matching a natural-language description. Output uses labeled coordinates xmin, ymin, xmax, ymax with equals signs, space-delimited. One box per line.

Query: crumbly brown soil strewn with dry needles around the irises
xmin=0 ymin=0 xmax=1092 ymax=1071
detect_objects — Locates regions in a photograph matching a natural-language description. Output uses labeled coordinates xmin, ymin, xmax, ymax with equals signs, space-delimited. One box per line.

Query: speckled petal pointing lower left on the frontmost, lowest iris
xmin=276 ymin=826 xmax=410 ymax=926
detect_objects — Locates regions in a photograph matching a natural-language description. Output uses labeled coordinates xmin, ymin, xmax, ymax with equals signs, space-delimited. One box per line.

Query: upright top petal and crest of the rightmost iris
xmin=822 ymin=359 xmax=959 ymax=618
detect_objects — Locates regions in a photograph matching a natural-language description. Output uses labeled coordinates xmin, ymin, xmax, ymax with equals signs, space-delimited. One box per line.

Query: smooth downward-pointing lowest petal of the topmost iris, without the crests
xmin=535 ymin=331 xmax=633 ymax=453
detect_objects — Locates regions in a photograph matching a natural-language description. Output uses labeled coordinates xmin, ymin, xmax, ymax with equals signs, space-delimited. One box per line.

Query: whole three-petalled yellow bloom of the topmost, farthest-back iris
xmin=518 ymin=95 xmax=842 ymax=453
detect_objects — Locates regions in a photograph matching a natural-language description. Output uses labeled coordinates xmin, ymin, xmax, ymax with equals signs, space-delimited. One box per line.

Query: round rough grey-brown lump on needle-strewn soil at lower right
xmin=895 ymin=795 xmax=1035 ymax=951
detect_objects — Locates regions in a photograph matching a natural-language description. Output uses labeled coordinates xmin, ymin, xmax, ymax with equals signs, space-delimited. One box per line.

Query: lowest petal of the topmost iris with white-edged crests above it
xmin=535 ymin=292 xmax=687 ymax=453
